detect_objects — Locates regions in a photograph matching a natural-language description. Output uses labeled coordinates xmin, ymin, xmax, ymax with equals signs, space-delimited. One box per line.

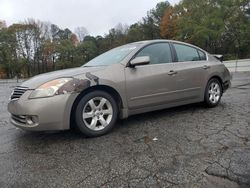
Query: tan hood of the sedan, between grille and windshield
xmin=21 ymin=67 xmax=105 ymax=89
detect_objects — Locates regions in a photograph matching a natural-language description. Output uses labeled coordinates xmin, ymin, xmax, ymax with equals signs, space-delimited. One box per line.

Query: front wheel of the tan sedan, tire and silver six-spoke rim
xmin=75 ymin=90 xmax=118 ymax=137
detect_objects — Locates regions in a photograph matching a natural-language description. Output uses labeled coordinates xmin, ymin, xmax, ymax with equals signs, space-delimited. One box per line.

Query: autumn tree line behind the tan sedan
xmin=0 ymin=0 xmax=250 ymax=78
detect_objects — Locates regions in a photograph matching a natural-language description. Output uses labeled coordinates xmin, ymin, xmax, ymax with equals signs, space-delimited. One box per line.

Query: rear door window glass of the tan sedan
xmin=173 ymin=44 xmax=200 ymax=62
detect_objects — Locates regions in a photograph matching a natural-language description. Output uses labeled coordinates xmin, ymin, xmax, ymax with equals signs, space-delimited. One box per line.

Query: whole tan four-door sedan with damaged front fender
xmin=8 ymin=40 xmax=231 ymax=136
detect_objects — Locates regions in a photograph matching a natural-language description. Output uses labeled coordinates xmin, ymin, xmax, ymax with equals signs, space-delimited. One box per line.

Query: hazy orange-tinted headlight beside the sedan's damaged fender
xmin=29 ymin=78 xmax=72 ymax=99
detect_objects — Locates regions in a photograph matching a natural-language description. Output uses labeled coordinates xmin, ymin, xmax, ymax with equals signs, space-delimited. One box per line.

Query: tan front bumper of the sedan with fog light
xmin=8 ymin=90 xmax=78 ymax=131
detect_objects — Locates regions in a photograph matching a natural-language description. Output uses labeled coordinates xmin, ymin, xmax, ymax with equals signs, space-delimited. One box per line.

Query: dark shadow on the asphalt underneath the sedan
xmin=14 ymin=103 xmax=215 ymax=144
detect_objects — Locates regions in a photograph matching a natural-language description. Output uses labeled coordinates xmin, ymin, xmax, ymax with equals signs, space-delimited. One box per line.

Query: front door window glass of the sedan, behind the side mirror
xmin=136 ymin=43 xmax=172 ymax=64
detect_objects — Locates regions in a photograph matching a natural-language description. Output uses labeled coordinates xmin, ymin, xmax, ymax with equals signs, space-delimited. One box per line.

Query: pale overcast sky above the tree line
xmin=0 ymin=0 xmax=180 ymax=36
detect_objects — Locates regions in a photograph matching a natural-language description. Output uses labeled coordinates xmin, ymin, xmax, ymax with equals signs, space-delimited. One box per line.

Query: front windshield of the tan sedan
xmin=83 ymin=44 xmax=137 ymax=67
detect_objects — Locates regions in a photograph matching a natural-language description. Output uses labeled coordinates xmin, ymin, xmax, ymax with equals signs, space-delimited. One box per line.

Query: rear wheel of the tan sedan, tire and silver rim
xmin=204 ymin=78 xmax=223 ymax=108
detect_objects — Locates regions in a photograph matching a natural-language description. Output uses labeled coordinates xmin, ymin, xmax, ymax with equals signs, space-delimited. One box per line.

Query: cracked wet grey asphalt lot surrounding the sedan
xmin=0 ymin=73 xmax=250 ymax=188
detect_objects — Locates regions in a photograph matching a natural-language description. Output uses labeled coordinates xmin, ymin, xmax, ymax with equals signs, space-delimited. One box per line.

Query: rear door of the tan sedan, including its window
xmin=172 ymin=43 xmax=210 ymax=100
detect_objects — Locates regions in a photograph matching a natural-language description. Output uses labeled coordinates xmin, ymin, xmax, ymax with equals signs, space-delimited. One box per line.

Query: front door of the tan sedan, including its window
xmin=125 ymin=42 xmax=176 ymax=110
